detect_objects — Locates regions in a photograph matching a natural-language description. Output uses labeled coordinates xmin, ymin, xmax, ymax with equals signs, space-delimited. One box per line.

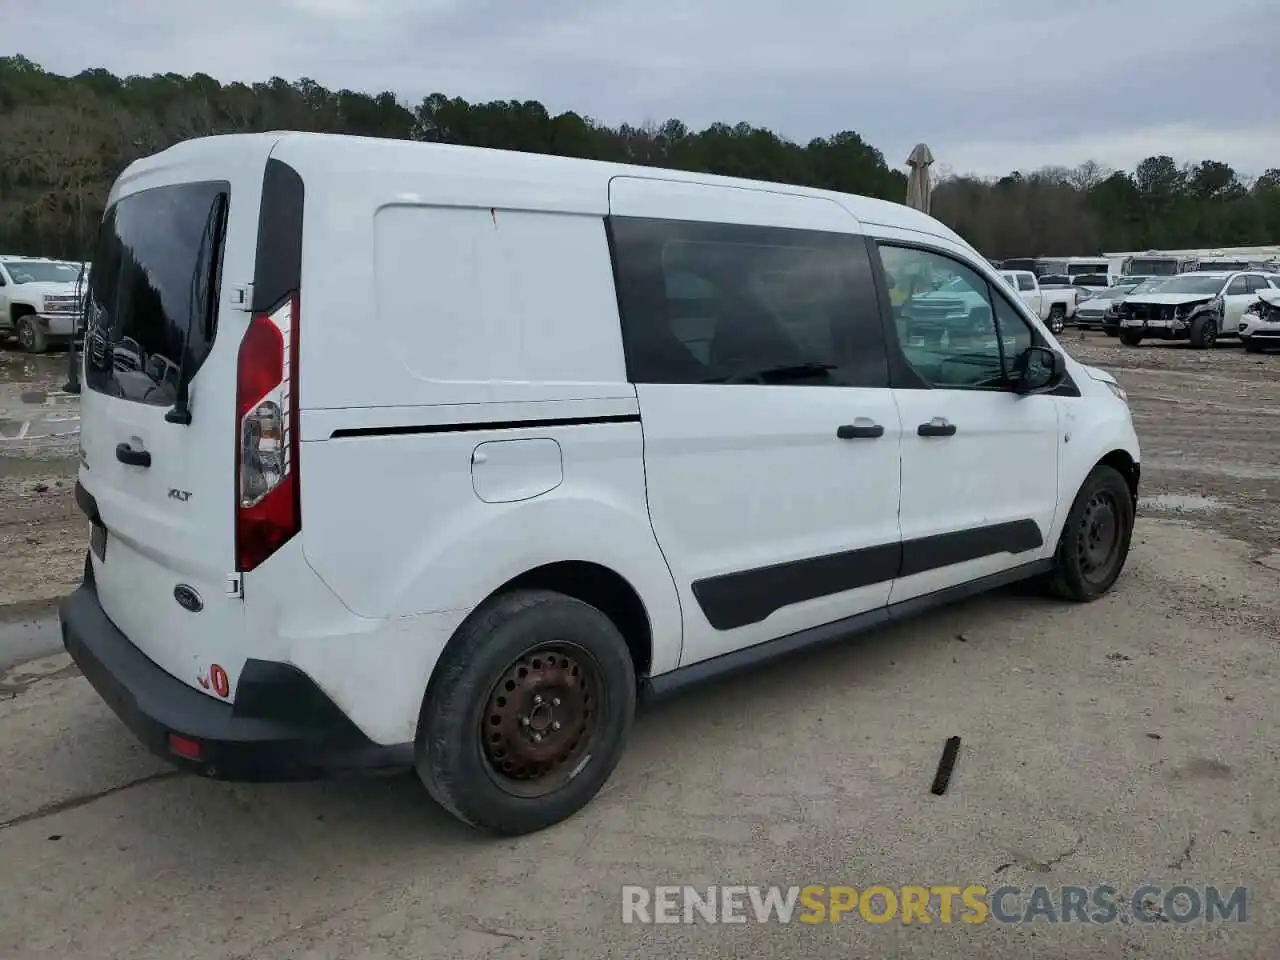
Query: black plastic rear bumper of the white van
xmin=59 ymin=570 xmax=413 ymax=782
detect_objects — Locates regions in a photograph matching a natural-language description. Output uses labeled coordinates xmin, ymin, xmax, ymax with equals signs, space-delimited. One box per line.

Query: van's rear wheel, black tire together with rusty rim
xmin=415 ymin=590 xmax=636 ymax=836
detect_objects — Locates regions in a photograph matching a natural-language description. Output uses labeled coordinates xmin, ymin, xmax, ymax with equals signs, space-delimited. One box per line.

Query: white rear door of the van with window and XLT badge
xmin=79 ymin=154 xmax=270 ymax=698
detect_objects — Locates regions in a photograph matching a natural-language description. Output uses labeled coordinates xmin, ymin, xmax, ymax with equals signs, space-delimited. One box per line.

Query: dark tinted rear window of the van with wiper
xmin=84 ymin=182 xmax=230 ymax=406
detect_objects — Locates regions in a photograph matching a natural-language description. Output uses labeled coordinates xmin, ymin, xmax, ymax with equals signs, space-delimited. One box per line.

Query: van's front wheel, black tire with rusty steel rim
xmin=1050 ymin=463 xmax=1134 ymax=603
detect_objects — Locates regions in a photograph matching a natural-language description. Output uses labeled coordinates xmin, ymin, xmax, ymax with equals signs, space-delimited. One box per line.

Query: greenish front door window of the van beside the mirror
xmin=879 ymin=243 xmax=1033 ymax=390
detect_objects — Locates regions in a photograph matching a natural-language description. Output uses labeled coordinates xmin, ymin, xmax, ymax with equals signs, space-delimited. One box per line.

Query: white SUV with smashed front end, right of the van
xmin=1120 ymin=273 xmax=1274 ymax=349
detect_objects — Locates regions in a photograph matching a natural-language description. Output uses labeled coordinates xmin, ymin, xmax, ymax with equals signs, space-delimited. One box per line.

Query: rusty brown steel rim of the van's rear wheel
xmin=479 ymin=641 xmax=608 ymax=800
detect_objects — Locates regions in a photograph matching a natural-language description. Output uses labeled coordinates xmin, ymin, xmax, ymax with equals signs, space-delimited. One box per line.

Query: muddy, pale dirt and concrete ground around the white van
xmin=0 ymin=333 xmax=1280 ymax=960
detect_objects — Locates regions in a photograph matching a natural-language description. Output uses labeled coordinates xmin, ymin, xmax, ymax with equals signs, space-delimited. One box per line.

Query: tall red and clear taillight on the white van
xmin=236 ymin=294 xmax=302 ymax=571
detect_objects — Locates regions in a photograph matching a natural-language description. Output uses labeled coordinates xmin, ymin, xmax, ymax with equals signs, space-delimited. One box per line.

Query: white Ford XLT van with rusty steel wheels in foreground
xmin=61 ymin=133 xmax=1139 ymax=833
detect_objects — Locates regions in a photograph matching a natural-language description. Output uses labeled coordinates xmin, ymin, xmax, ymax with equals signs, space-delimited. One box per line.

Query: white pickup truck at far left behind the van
xmin=0 ymin=255 xmax=81 ymax=353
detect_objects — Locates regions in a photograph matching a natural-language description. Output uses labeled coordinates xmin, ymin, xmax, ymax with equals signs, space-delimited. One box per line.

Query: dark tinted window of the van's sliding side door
xmin=608 ymin=218 xmax=888 ymax=387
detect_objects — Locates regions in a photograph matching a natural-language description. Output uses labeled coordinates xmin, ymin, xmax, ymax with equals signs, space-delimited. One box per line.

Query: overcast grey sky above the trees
xmin=10 ymin=0 xmax=1280 ymax=175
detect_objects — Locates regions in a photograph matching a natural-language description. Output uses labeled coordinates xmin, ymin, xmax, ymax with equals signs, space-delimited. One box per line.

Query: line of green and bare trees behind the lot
xmin=0 ymin=56 xmax=1280 ymax=259
